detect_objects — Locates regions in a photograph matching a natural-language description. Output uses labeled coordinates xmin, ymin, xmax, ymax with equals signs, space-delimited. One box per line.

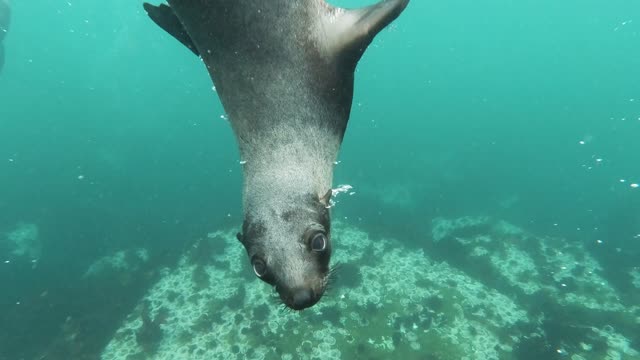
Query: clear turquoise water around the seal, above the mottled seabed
xmin=0 ymin=0 xmax=640 ymax=359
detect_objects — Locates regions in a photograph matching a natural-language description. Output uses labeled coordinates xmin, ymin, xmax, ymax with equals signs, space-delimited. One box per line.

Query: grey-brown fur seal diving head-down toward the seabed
xmin=144 ymin=0 xmax=409 ymax=310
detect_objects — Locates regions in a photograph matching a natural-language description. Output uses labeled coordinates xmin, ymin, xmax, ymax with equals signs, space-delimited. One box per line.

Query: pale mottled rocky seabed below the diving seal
xmin=85 ymin=217 xmax=640 ymax=360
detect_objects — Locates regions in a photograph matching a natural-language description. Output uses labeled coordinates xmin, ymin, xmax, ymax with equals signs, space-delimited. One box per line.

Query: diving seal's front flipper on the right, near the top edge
xmin=322 ymin=0 xmax=409 ymax=67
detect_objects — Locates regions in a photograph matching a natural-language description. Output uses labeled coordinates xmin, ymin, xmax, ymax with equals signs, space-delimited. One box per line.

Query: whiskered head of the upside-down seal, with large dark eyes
xmin=238 ymin=190 xmax=331 ymax=310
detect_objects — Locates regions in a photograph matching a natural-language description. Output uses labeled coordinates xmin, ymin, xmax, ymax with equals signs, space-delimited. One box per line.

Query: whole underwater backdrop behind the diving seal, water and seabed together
xmin=0 ymin=0 xmax=640 ymax=360
